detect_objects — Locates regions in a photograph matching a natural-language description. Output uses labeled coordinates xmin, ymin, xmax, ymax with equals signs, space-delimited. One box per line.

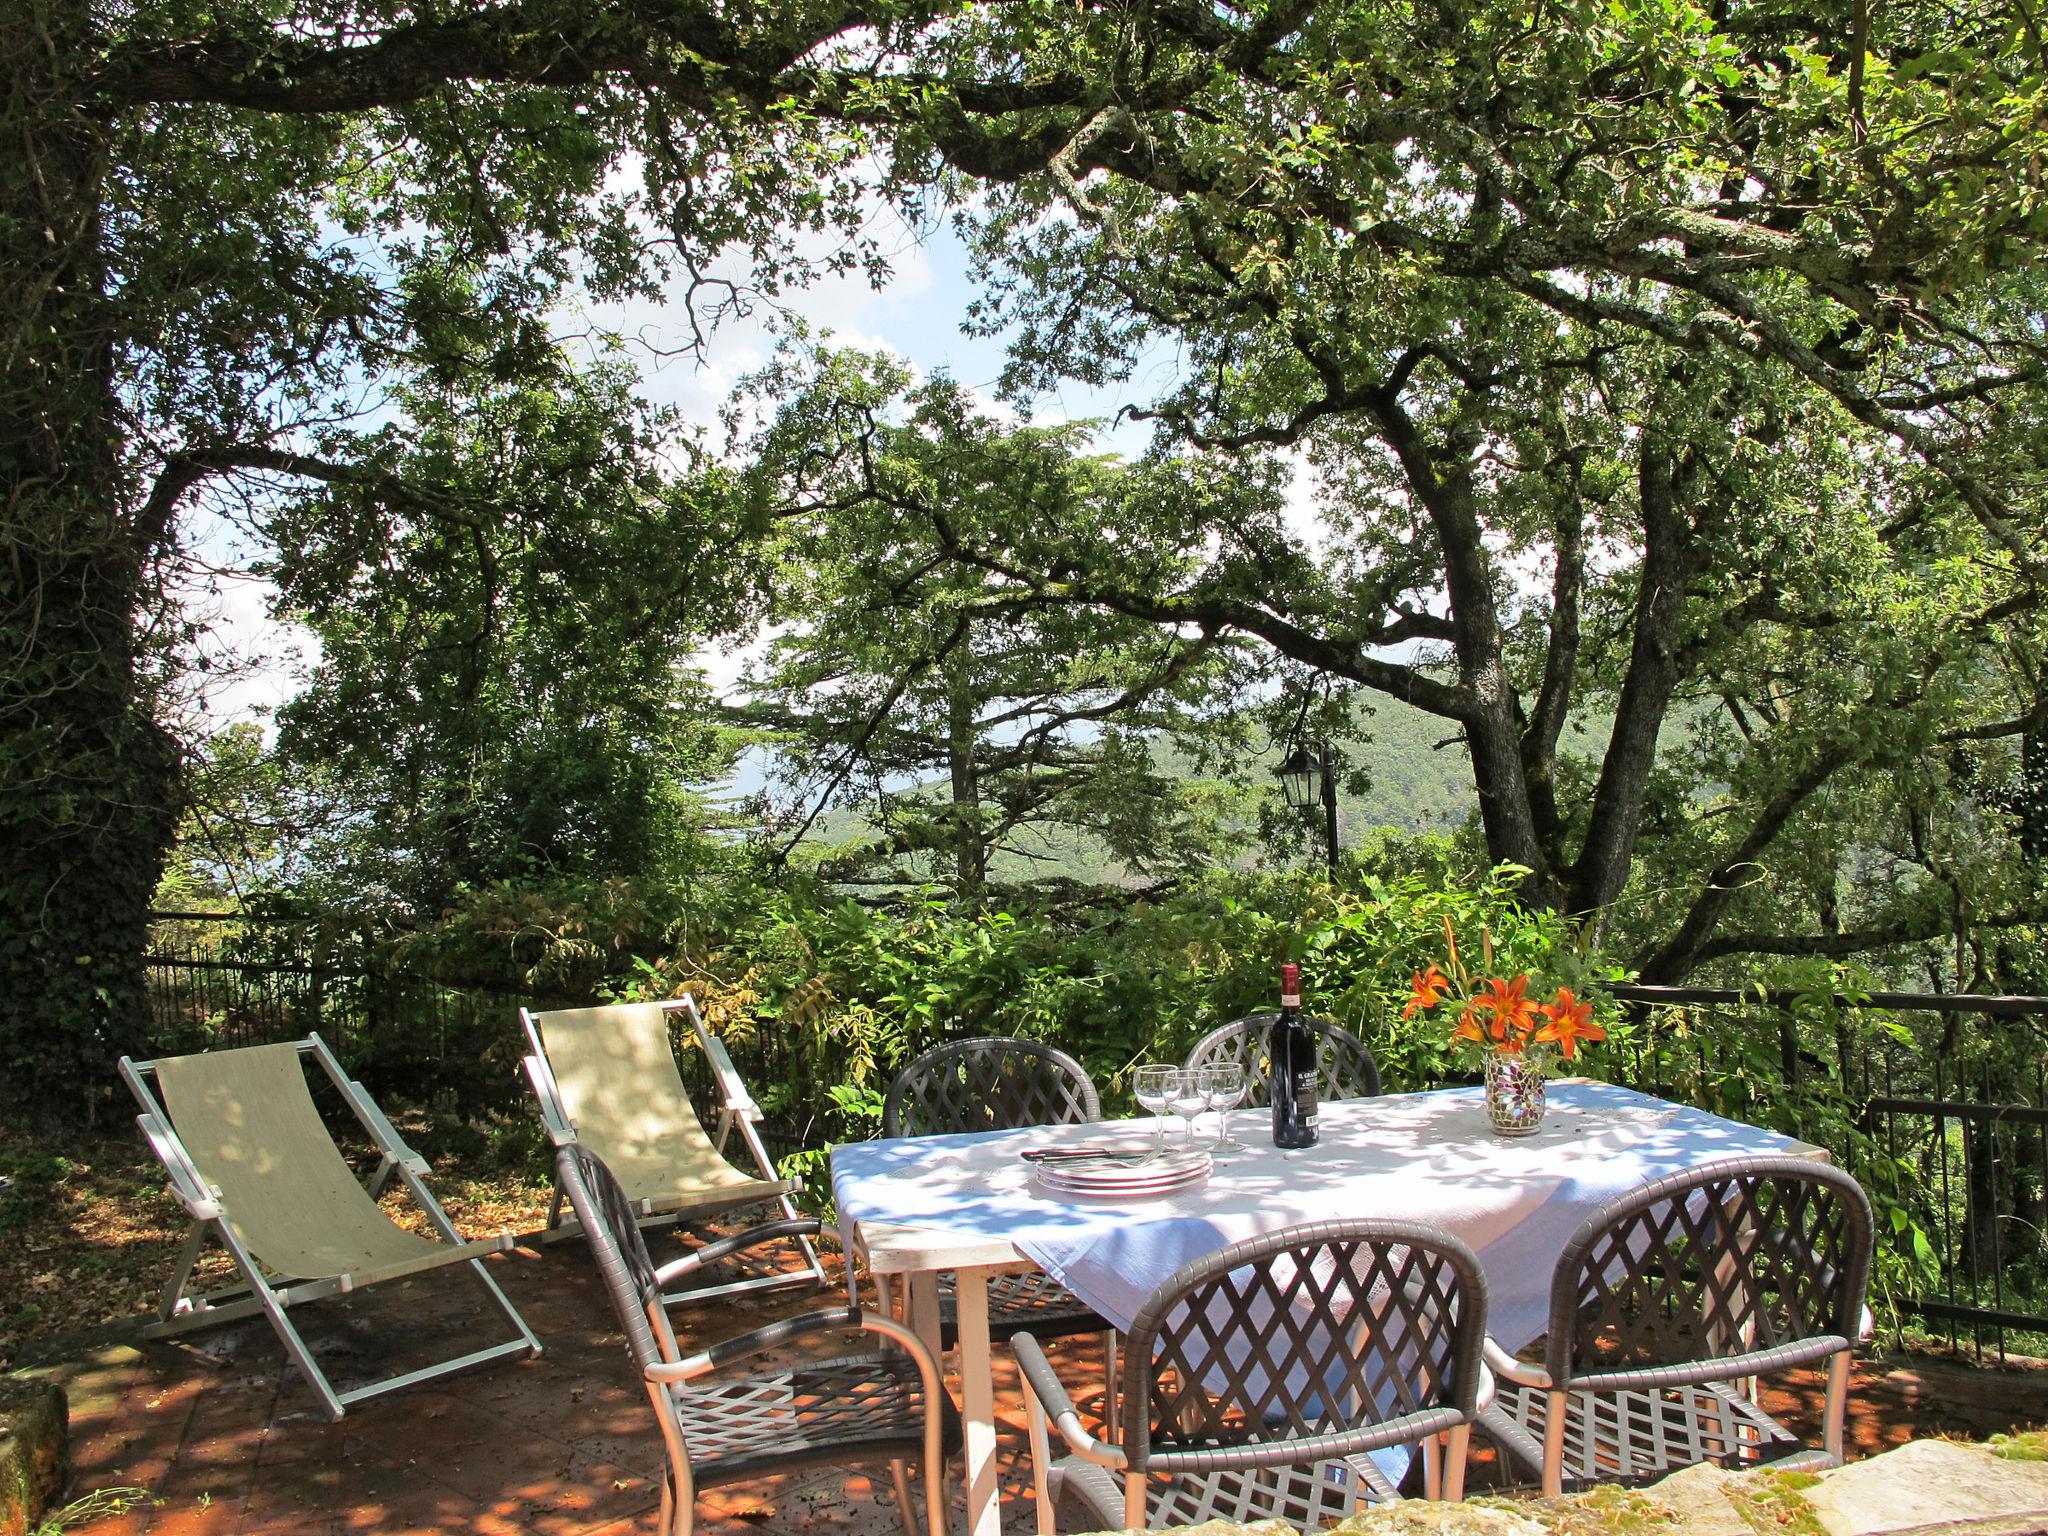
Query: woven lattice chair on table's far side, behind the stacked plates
xmin=883 ymin=1036 xmax=1116 ymax=1360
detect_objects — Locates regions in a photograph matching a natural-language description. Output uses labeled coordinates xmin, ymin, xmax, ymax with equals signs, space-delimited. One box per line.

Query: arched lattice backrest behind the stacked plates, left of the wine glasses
xmin=883 ymin=1038 xmax=1102 ymax=1137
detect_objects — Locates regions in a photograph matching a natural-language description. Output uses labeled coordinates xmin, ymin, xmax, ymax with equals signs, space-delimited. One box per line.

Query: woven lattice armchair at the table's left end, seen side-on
xmin=555 ymin=1143 xmax=961 ymax=1536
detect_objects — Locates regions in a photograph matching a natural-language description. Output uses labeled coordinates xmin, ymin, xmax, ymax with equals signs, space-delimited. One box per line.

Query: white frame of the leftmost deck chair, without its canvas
xmin=119 ymin=1032 xmax=541 ymax=1419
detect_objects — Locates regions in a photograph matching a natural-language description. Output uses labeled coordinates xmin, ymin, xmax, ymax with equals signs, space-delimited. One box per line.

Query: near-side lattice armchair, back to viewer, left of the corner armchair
xmin=1012 ymin=1221 xmax=1487 ymax=1536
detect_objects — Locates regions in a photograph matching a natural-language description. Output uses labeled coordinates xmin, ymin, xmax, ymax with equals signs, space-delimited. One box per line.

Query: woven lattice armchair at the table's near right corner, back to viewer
xmin=1481 ymin=1157 xmax=1872 ymax=1495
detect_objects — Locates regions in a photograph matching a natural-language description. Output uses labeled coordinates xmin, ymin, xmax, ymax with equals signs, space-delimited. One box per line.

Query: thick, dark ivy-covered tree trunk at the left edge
xmin=0 ymin=0 xmax=178 ymax=1124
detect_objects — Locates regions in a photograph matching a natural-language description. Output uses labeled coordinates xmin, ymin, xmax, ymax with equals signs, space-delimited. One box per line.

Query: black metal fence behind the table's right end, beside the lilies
xmin=1616 ymin=987 xmax=2048 ymax=1360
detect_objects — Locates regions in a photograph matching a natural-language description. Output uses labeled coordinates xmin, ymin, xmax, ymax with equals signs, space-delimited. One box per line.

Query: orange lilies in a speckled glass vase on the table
xmin=1401 ymin=920 xmax=1608 ymax=1137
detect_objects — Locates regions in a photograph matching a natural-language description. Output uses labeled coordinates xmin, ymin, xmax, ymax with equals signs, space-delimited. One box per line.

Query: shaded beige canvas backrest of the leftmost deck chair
xmin=150 ymin=1042 xmax=430 ymax=1280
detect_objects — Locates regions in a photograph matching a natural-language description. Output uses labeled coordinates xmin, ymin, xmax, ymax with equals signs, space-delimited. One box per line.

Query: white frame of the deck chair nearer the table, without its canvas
xmin=518 ymin=995 xmax=827 ymax=1307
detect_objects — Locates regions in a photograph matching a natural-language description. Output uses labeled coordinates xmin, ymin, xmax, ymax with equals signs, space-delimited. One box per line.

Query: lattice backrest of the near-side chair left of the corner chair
xmin=1122 ymin=1221 xmax=1487 ymax=1475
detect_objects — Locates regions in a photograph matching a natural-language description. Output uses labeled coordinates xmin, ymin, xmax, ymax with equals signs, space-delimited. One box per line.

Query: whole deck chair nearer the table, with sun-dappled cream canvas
xmin=520 ymin=997 xmax=825 ymax=1307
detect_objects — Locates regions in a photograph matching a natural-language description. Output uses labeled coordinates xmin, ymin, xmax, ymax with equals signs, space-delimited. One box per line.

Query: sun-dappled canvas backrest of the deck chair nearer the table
xmin=522 ymin=1004 xmax=735 ymax=1186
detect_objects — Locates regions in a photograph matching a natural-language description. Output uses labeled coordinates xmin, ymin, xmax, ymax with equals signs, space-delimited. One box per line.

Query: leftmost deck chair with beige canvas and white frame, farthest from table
xmin=121 ymin=1034 xmax=541 ymax=1419
